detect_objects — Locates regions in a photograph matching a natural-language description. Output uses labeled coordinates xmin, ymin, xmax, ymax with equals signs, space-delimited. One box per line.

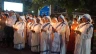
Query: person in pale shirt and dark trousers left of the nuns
xmin=4 ymin=11 xmax=17 ymax=46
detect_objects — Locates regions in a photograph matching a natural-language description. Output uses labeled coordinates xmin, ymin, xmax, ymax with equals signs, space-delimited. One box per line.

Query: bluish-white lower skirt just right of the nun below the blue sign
xmin=51 ymin=32 xmax=61 ymax=54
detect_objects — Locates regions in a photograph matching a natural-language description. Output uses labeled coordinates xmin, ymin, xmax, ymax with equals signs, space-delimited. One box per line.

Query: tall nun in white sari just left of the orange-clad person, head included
xmin=55 ymin=15 xmax=70 ymax=54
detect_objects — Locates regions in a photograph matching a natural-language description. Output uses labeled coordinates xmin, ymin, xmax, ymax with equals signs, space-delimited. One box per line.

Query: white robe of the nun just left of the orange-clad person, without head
xmin=54 ymin=22 xmax=70 ymax=54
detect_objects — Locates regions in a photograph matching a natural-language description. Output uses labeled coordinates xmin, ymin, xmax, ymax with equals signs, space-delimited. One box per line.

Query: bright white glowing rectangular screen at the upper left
xmin=4 ymin=1 xmax=23 ymax=12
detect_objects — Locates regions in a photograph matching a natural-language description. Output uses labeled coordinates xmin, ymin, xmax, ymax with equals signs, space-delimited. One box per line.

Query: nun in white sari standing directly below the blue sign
xmin=40 ymin=16 xmax=52 ymax=54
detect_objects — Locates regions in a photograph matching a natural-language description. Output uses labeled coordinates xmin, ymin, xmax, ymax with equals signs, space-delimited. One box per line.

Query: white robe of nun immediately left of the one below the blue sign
xmin=31 ymin=23 xmax=41 ymax=52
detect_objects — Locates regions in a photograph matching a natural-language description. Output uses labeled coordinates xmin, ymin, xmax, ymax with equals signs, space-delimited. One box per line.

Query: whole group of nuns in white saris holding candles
xmin=13 ymin=14 xmax=93 ymax=54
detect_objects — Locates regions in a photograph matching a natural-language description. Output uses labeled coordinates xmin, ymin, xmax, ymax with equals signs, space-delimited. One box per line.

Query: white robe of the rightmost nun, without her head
xmin=74 ymin=23 xmax=93 ymax=54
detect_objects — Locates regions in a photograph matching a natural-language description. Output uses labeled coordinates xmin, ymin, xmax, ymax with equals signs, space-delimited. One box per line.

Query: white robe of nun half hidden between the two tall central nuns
xmin=51 ymin=22 xmax=60 ymax=54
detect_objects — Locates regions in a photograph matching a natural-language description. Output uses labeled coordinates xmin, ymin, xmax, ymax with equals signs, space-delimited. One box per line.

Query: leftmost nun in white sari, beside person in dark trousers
xmin=13 ymin=18 xmax=25 ymax=50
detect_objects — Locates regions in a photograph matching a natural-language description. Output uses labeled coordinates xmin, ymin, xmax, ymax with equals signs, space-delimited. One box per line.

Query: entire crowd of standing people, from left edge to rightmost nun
xmin=0 ymin=11 xmax=93 ymax=54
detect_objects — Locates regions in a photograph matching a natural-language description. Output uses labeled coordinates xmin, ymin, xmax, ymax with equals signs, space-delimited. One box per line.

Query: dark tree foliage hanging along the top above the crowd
xmin=21 ymin=0 xmax=96 ymax=14
